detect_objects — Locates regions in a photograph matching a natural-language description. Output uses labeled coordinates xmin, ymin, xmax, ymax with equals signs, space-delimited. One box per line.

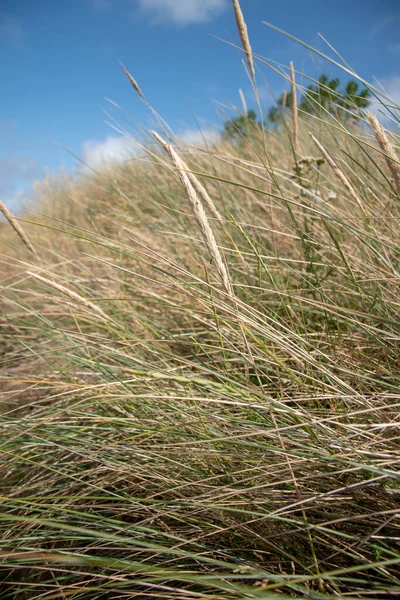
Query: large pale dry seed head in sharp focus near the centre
xmin=151 ymin=131 xmax=234 ymax=296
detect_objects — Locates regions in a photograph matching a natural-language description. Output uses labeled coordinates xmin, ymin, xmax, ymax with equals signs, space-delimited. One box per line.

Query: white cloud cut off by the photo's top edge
xmin=137 ymin=0 xmax=229 ymax=25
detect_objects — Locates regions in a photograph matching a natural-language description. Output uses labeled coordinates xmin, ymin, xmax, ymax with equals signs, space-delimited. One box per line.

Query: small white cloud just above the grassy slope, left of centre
xmin=82 ymin=135 xmax=136 ymax=167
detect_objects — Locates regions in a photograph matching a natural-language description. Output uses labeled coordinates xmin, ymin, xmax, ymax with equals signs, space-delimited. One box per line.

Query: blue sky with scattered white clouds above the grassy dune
xmin=0 ymin=0 xmax=400 ymax=206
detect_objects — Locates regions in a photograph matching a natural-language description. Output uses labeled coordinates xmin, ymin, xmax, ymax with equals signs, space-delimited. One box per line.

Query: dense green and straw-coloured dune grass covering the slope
xmin=0 ymin=3 xmax=400 ymax=600
